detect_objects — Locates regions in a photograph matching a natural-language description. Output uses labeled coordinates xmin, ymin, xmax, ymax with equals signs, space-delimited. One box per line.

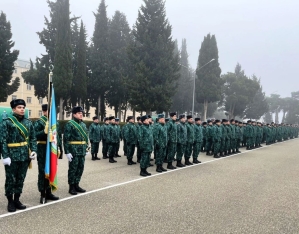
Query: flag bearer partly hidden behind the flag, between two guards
xmin=34 ymin=104 xmax=59 ymax=204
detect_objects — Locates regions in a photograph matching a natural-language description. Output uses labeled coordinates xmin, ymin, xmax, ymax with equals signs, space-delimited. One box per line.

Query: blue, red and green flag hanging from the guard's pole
xmin=45 ymin=86 xmax=58 ymax=191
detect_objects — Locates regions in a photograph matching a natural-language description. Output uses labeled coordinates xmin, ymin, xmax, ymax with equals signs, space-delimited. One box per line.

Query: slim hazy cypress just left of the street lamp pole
xmin=172 ymin=39 xmax=195 ymax=113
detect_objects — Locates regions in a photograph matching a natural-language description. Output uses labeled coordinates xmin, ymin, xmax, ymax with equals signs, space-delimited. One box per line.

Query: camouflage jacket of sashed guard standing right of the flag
xmin=63 ymin=118 xmax=88 ymax=156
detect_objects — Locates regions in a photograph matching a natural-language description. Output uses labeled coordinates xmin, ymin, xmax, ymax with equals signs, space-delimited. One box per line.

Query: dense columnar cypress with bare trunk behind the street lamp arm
xmin=196 ymin=34 xmax=222 ymax=120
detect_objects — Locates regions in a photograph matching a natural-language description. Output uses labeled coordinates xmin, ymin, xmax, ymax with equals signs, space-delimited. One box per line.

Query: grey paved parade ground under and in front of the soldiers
xmin=0 ymin=139 xmax=299 ymax=234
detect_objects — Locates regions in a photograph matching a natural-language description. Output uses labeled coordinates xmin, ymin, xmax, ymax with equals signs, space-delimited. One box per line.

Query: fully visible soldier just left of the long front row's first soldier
xmin=124 ymin=116 xmax=138 ymax=165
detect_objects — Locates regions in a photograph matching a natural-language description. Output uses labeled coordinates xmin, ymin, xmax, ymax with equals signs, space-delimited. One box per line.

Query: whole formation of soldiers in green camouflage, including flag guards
xmin=0 ymin=99 xmax=298 ymax=212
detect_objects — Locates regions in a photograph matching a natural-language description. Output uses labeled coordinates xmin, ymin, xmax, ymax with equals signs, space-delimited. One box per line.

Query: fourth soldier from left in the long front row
xmin=176 ymin=115 xmax=187 ymax=167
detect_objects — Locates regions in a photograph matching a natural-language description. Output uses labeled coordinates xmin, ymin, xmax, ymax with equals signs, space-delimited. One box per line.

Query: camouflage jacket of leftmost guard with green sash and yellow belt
xmin=2 ymin=114 xmax=37 ymax=161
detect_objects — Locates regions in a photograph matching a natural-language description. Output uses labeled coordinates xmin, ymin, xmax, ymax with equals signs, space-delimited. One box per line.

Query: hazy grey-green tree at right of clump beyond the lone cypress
xmin=244 ymin=76 xmax=269 ymax=120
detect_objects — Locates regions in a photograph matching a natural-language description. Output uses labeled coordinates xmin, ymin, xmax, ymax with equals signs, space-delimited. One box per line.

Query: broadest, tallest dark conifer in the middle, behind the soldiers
xmin=129 ymin=0 xmax=179 ymax=113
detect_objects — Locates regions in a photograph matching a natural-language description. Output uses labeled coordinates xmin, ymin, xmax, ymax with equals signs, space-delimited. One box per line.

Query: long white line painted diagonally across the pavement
xmin=0 ymin=138 xmax=298 ymax=219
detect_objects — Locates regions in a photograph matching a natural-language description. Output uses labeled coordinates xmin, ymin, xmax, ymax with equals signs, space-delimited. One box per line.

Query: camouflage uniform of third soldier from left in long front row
xmin=167 ymin=119 xmax=178 ymax=163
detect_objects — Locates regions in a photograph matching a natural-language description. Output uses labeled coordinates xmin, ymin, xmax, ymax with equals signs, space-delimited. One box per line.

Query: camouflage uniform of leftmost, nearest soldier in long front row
xmin=137 ymin=124 xmax=154 ymax=169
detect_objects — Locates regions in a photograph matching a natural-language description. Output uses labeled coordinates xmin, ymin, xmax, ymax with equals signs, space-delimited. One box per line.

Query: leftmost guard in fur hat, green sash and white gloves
xmin=2 ymin=99 xmax=37 ymax=212
